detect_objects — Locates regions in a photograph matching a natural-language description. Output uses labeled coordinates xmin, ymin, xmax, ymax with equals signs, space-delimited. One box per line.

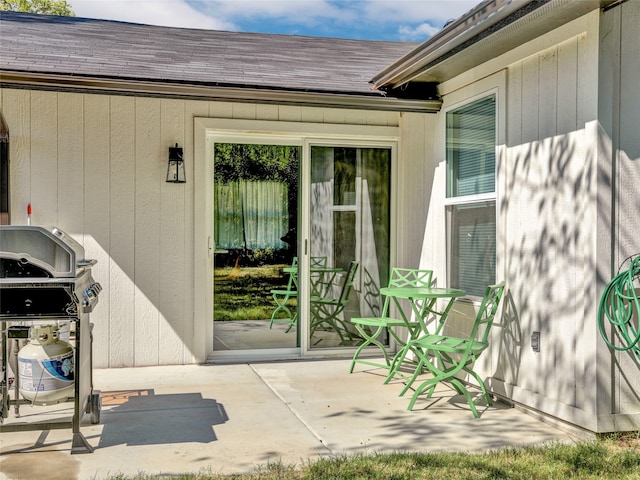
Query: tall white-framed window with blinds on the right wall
xmin=446 ymin=95 xmax=496 ymax=297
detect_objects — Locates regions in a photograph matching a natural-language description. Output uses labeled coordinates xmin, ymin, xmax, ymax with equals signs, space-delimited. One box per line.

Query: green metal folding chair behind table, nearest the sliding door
xmin=349 ymin=267 xmax=433 ymax=373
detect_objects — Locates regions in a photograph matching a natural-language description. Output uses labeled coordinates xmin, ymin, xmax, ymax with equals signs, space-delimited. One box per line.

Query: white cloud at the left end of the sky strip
xmin=70 ymin=0 xmax=237 ymax=30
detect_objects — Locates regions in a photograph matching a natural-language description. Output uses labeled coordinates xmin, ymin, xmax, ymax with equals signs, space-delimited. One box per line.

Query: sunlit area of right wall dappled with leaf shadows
xmin=493 ymin=120 xmax=640 ymax=420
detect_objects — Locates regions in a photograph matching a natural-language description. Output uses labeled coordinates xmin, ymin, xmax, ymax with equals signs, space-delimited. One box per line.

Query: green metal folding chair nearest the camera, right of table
xmin=400 ymin=282 xmax=504 ymax=418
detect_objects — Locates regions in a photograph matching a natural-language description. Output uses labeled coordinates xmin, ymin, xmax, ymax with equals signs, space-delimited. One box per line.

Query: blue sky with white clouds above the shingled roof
xmin=68 ymin=0 xmax=480 ymax=41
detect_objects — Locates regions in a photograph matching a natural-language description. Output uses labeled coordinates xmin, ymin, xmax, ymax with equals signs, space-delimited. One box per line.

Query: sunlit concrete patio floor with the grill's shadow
xmin=0 ymin=359 xmax=584 ymax=480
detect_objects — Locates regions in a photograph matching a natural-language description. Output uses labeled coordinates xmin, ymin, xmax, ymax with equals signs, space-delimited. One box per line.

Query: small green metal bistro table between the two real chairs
xmin=380 ymin=287 xmax=467 ymax=383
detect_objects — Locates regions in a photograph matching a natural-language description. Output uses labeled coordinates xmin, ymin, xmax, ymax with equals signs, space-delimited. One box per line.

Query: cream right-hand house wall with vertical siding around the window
xmin=412 ymin=9 xmax=640 ymax=431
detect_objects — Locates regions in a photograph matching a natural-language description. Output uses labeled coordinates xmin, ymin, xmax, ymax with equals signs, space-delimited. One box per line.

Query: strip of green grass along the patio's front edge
xmin=104 ymin=439 xmax=640 ymax=480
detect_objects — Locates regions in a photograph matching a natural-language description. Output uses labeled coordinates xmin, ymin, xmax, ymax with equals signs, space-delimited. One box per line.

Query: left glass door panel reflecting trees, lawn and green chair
xmin=212 ymin=143 xmax=301 ymax=352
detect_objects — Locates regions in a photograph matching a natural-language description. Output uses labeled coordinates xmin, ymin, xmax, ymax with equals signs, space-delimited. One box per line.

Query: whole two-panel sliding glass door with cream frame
xmin=196 ymin=120 xmax=395 ymax=359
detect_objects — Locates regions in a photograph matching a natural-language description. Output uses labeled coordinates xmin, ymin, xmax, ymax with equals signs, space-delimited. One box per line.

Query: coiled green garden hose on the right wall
xmin=598 ymin=254 xmax=640 ymax=360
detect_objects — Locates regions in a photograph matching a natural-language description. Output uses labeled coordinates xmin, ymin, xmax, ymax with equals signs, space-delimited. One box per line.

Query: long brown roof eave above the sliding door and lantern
xmin=0 ymin=70 xmax=442 ymax=113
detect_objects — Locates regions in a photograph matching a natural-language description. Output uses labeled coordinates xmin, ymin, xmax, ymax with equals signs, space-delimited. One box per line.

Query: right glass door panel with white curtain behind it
xmin=309 ymin=145 xmax=392 ymax=349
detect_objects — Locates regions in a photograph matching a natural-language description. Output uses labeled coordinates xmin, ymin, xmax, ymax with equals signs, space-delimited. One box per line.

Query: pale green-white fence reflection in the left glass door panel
xmin=214 ymin=180 xmax=289 ymax=250
